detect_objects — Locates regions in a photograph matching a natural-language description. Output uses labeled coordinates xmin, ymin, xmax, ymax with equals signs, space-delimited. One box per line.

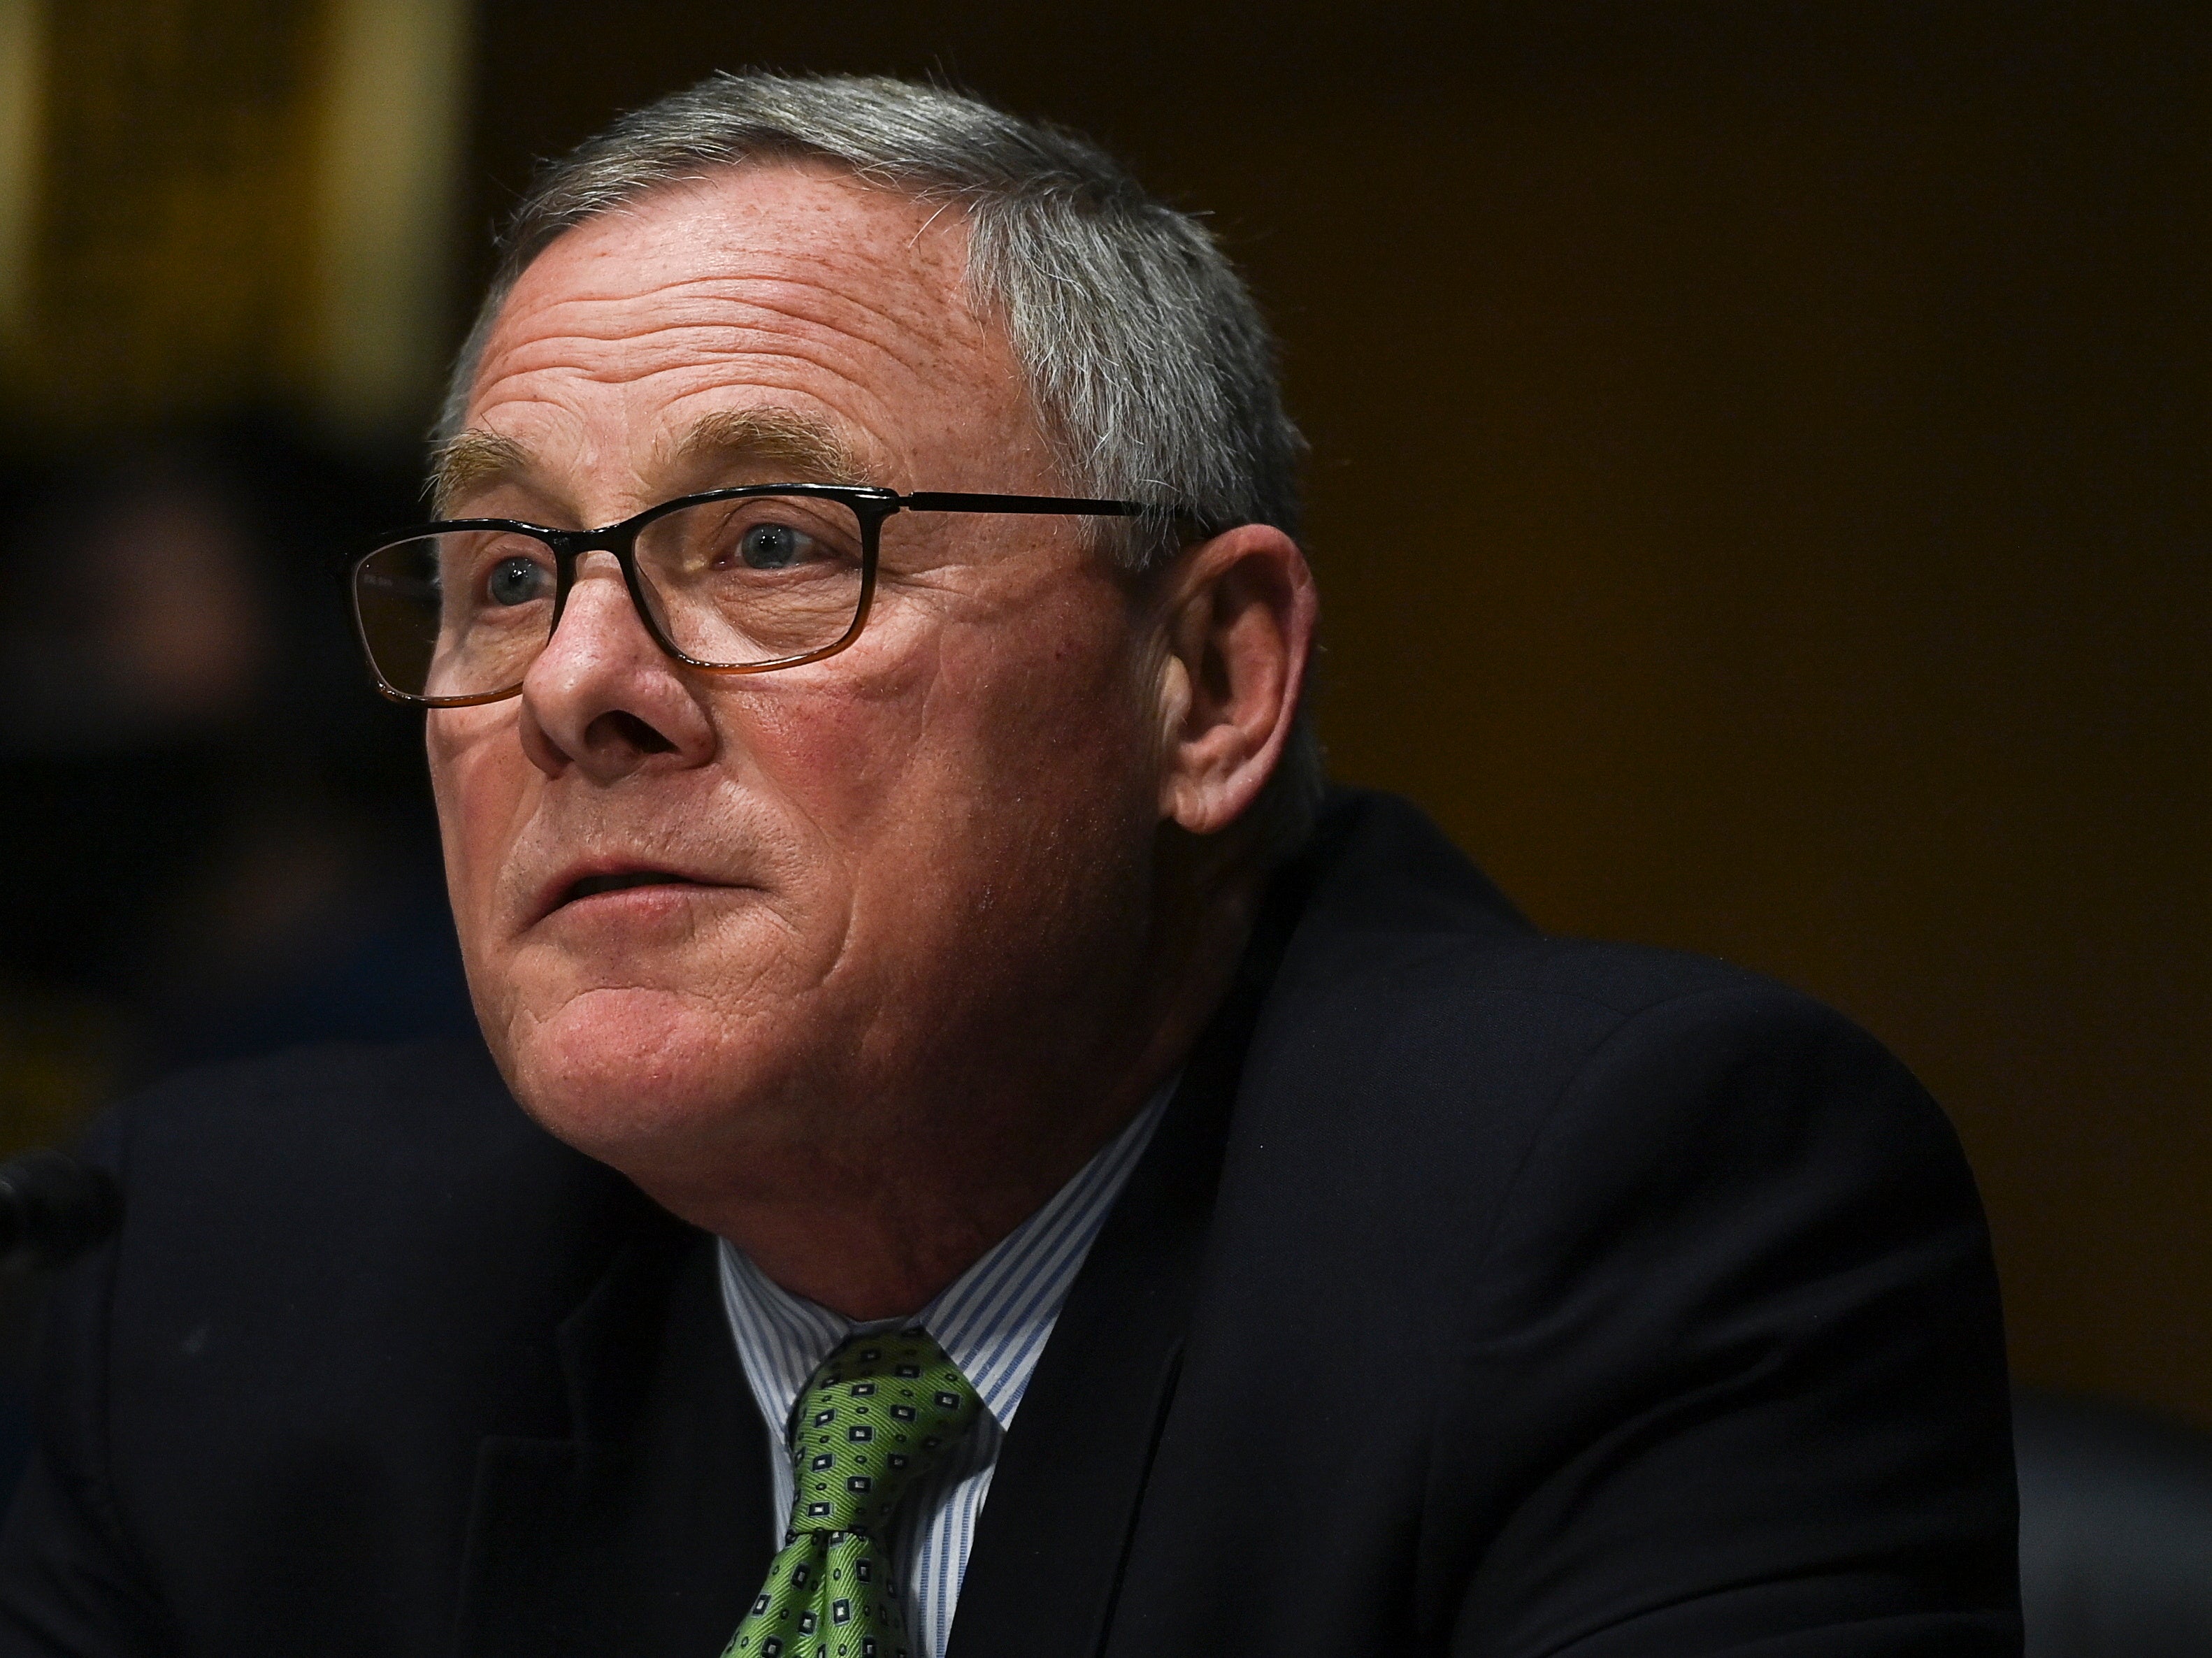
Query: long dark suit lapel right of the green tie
xmin=947 ymin=878 xmax=1305 ymax=1658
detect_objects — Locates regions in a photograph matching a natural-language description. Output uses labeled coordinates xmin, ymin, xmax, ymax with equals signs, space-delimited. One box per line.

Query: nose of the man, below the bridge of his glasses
xmin=520 ymin=553 xmax=714 ymax=783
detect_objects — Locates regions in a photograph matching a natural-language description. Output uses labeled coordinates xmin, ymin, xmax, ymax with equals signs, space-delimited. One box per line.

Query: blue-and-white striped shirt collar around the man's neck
xmin=721 ymin=1076 xmax=1177 ymax=1428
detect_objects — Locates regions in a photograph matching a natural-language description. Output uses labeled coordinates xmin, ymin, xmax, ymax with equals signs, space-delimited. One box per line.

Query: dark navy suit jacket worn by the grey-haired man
xmin=0 ymin=796 xmax=2018 ymax=1658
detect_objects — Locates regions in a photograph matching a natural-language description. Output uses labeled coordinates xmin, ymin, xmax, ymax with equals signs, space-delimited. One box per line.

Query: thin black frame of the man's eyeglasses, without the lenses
xmin=345 ymin=484 xmax=1214 ymax=707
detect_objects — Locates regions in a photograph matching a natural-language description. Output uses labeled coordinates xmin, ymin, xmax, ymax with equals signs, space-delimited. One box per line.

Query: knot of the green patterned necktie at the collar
xmin=792 ymin=1331 xmax=982 ymax=1536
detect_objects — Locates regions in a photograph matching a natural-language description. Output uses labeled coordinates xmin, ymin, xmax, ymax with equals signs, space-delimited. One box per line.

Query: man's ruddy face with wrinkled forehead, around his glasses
xmin=429 ymin=166 xmax=1185 ymax=1187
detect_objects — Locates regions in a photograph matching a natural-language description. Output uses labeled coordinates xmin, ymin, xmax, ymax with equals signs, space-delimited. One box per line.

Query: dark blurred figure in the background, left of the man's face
xmin=0 ymin=420 xmax=473 ymax=1490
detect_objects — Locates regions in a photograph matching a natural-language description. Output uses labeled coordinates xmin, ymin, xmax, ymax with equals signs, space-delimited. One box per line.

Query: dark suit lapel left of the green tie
xmin=456 ymin=1218 xmax=774 ymax=1658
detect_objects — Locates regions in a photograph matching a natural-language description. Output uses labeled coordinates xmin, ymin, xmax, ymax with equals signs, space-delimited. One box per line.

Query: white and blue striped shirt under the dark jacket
xmin=721 ymin=1079 xmax=1175 ymax=1658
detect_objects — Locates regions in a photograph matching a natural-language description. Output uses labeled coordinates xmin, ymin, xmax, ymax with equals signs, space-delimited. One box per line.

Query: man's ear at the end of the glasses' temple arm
xmin=1155 ymin=524 xmax=1319 ymax=835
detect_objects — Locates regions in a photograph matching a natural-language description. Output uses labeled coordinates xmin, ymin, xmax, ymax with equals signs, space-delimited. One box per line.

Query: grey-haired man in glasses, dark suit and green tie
xmin=0 ymin=75 xmax=2018 ymax=1658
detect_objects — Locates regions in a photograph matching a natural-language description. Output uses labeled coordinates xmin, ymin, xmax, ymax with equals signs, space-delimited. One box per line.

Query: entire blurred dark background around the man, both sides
xmin=0 ymin=0 xmax=2212 ymax=1636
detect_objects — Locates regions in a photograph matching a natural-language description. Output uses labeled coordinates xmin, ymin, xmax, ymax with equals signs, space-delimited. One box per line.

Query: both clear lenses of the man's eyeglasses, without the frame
xmin=354 ymin=495 xmax=863 ymax=698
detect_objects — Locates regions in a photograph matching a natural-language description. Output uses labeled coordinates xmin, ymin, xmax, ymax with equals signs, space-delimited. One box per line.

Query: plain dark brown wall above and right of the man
xmin=4 ymin=0 xmax=2212 ymax=1422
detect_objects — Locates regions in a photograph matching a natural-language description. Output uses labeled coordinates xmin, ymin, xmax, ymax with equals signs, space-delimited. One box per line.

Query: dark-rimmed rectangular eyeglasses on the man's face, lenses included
xmin=350 ymin=484 xmax=1195 ymax=707
